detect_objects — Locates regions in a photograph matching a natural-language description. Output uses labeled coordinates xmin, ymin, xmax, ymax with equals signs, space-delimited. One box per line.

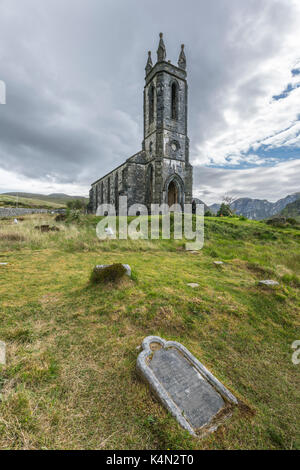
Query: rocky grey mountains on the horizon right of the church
xmin=210 ymin=193 xmax=300 ymax=220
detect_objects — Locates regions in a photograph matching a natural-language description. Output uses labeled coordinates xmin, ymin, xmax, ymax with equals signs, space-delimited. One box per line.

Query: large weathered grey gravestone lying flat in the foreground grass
xmin=137 ymin=336 xmax=238 ymax=436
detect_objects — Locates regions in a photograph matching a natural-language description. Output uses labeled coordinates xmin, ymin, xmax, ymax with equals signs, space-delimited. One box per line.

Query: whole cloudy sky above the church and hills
xmin=0 ymin=0 xmax=300 ymax=203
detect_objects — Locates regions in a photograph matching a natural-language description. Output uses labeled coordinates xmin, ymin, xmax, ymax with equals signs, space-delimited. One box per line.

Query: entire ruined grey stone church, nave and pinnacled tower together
xmin=89 ymin=33 xmax=193 ymax=213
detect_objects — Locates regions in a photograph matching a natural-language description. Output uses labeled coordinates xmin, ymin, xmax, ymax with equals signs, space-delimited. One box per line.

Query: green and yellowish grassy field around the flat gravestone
xmin=0 ymin=216 xmax=300 ymax=450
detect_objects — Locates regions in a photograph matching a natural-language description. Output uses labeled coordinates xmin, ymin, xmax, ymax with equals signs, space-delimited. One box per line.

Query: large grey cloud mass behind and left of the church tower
xmin=0 ymin=0 xmax=292 ymax=194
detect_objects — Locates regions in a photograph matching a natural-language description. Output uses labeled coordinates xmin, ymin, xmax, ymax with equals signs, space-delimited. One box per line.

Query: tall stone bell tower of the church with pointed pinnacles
xmin=143 ymin=33 xmax=193 ymax=206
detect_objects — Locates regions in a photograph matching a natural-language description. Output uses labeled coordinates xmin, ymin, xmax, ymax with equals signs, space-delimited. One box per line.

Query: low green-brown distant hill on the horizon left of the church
xmin=0 ymin=192 xmax=89 ymax=208
